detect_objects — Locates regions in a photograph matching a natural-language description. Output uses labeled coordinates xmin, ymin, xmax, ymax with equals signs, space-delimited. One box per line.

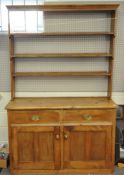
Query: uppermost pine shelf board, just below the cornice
xmin=10 ymin=32 xmax=114 ymax=37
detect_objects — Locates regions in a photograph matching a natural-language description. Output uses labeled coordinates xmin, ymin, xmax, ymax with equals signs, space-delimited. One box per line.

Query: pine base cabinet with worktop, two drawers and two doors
xmin=6 ymin=98 xmax=116 ymax=174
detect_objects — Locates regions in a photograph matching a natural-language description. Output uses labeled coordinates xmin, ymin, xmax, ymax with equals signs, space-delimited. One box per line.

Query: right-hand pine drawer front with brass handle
xmin=63 ymin=109 xmax=116 ymax=122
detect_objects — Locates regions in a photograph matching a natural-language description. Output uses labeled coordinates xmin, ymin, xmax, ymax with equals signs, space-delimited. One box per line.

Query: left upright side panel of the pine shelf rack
xmin=8 ymin=11 xmax=15 ymax=100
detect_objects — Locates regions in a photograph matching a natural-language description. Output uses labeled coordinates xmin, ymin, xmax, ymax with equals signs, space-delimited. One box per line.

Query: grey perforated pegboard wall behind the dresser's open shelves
xmin=0 ymin=2 xmax=124 ymax=92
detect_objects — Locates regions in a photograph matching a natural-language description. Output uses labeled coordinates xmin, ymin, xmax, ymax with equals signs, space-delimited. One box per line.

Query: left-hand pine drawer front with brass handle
xmin=9 ymin=110 xmax=60 ymax=124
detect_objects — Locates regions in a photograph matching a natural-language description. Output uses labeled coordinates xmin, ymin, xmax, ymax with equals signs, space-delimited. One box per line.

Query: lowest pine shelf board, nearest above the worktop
xmin=13 ymin=71 xmax=111 ymax=77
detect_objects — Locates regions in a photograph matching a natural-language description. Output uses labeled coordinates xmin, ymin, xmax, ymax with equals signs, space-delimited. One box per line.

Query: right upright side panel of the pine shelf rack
xmin=108 ymin=10 xmax=116 ymax=99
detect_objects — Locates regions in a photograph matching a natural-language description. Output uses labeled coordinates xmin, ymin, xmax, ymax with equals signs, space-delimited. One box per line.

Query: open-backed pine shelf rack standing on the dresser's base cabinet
xmin=7 ymin=4 xmax=119 ymax=99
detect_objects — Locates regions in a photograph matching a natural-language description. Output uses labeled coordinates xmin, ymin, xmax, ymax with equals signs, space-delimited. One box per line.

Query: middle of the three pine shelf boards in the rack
xmin=11 ymin=53 xmax=112 ymax=59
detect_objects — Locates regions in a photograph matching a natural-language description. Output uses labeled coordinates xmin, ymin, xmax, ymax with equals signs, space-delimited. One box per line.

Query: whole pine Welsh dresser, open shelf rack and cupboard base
xmin=6 ymin=4 xmax=119 ymax=174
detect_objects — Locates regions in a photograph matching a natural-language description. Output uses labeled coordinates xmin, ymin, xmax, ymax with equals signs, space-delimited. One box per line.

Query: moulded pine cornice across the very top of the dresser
xmin=7 ymin=4 xmax=119 ymax=12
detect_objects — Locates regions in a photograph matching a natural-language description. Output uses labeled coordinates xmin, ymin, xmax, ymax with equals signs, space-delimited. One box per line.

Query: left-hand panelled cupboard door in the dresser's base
xmin=12 ymin=126 xmax=60 ymax=170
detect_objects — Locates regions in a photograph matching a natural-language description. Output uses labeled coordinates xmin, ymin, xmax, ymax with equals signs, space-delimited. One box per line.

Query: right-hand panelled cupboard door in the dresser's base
xmin=63 ymin=125 xmax=112 ymax=169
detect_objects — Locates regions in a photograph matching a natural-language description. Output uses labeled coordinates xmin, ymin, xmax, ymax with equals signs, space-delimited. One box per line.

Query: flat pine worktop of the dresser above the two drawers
xmin=6 ymin=97 xmax=116 ymax=110
